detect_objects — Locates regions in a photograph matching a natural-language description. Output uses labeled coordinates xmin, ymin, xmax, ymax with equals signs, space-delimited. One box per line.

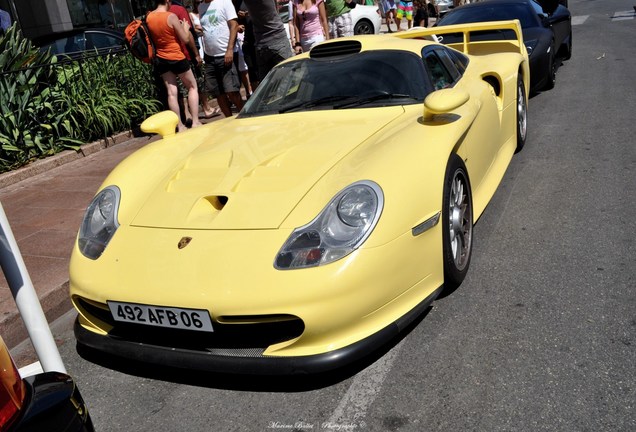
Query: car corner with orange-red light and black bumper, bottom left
xmin=0 ymin=337 xmax=94 ymax=432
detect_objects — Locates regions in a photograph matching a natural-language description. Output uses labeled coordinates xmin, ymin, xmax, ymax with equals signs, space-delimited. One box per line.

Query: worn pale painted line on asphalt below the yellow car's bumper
xmin=322 ymin=339 xmax=404 ymax=429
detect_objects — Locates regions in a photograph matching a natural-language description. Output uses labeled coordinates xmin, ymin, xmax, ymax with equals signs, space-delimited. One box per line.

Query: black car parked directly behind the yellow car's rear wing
xmin=436 ymin=0 xmax=572 ymax=92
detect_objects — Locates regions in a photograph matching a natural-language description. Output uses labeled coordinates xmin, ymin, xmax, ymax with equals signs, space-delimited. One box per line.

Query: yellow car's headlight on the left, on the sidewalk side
xmin=77 ymin=186 xmax=121 ymax=259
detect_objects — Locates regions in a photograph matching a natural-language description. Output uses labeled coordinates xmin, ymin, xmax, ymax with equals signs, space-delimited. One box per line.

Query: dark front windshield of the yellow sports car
xmin=239 ymin=50 xmax=431 ymax=117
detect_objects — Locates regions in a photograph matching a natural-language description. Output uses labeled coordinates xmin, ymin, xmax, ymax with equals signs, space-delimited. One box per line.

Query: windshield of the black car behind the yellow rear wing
xmin=438 ymin=3 xmax=540 ymax=28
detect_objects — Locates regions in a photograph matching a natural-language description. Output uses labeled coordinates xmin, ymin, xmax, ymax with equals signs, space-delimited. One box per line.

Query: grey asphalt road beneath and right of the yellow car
xmin=17 ymin=0 xmax=636 ymax=432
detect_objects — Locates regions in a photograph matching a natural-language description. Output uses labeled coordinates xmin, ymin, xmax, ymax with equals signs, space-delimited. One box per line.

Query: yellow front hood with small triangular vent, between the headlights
xmin=131 ymin=106 xmax=404 ymax=229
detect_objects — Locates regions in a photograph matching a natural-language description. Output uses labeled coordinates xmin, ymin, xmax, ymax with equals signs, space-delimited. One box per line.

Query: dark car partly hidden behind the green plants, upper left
xmin=33 ymin=28 xmax=126 ymax=59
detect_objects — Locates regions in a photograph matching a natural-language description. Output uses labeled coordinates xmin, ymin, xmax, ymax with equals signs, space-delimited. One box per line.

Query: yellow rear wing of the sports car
xmin=394 ymin=20 xmax=528 ymax=59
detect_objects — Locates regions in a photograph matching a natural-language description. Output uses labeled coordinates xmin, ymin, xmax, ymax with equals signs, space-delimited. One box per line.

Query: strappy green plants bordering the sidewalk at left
xmin=0 ymin=26 xmax=160 ymax=172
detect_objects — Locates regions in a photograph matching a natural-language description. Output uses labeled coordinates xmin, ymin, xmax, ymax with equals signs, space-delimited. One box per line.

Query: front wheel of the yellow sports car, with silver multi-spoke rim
xmin=442 ymin=154 xmax=473 ymax=289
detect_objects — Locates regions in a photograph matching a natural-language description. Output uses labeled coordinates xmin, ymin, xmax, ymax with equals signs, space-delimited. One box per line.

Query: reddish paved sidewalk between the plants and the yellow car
xmin=0 ymin=133 xmax=157 ymax=348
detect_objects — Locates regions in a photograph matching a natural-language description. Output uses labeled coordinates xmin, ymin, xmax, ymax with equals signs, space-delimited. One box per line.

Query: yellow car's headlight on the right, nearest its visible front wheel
xmin=274 ymin=181 xmax=384 ymax=270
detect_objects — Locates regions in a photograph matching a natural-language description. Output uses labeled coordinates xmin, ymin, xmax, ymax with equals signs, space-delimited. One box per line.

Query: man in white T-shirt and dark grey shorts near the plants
xmin=199 ymin=0 xmax=243 ymax=117
